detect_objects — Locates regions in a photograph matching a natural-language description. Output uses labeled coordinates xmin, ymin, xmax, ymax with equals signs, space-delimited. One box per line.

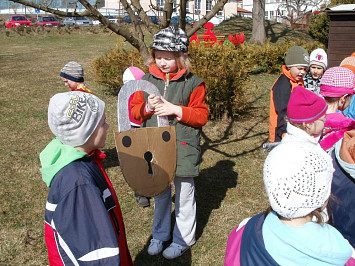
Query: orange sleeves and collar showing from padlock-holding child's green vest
xmin=131 ymin=64 xmax=208 ymax=127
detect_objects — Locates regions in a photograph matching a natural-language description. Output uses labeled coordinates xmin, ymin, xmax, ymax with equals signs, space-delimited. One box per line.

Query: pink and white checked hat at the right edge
xmin=320 ymin=67 xmax=355 ymax=97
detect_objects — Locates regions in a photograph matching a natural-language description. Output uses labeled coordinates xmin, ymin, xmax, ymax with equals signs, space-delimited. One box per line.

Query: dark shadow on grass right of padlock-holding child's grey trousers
xmin=195 ymin=160 xmax=238 ymax=240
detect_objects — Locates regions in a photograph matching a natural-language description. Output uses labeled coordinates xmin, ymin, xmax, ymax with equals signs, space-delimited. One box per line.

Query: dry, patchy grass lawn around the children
xmin=0 ymin=26 xmax=276 ymax=265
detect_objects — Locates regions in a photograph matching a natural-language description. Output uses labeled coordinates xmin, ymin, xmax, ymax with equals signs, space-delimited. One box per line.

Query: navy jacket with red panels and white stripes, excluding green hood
xmin=41 ymin=140 xmax=133 ymax=265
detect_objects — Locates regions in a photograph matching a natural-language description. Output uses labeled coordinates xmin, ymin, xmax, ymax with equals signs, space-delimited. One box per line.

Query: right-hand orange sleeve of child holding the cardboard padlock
xmin=179 ymin=82 xmax=208 ymax=127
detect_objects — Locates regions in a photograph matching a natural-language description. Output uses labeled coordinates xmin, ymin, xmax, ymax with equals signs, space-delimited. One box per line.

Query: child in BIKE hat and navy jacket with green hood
xmin=40 ymin=91 xmax=133 ymax=265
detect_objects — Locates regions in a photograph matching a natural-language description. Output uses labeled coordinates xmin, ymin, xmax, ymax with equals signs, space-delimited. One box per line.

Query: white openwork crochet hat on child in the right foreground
xmin=264 ymin=142 xmax=333 ymax=219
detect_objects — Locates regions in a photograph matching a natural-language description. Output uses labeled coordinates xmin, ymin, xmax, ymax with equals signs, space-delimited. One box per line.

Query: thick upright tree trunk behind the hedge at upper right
xmin=250 ymin=0 xmax=266 ymax=43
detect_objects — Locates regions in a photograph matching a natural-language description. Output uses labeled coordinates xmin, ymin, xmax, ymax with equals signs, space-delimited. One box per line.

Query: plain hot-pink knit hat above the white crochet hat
xmin=287 ymin=86 xmax=328 ymax=123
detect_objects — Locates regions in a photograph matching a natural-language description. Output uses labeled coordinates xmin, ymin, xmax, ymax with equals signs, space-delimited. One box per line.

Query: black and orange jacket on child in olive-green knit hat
xmin=269 ymin=65 xmax=304 ymax=142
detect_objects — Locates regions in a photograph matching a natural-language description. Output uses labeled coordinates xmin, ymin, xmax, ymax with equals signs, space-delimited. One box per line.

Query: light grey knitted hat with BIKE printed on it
xmin=48 ymin=91 xmax=105 ymax=147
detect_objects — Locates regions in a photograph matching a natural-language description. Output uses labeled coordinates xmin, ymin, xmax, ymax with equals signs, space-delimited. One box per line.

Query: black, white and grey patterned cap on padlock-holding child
xmin=150 ymin=26 xmax=190 ymax=53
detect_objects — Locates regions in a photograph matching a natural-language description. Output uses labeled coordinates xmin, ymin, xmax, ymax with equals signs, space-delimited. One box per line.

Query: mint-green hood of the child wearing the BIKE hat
xmin=39 ymin=138 xmax=87 ymax=187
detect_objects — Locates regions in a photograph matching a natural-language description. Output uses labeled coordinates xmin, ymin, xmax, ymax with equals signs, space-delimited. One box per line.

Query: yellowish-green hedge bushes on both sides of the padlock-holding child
xmin=92 ymin=41 xmax=324 ymax=119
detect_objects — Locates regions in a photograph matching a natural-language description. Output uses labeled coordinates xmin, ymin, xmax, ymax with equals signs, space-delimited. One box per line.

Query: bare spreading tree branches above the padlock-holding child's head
xmin=12 ymin=0 xmax=228 ymax=64
